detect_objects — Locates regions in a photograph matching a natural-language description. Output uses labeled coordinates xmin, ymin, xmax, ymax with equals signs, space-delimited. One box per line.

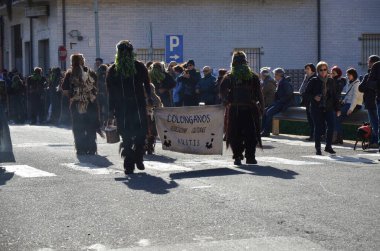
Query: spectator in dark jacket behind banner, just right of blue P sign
xmin=180 ymin=60 xmax=201 ymax=106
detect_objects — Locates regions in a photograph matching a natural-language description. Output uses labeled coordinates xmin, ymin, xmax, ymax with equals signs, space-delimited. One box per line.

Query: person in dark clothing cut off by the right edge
xmin=359 ymin=55 xmax=380 ymax=147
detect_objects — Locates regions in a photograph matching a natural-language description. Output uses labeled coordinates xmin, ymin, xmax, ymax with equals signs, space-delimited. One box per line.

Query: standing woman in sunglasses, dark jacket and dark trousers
xmin=305 ymin=61 xmax=340 ymax=155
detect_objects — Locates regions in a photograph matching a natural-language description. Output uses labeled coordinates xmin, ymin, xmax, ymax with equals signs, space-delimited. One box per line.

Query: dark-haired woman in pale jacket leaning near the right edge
xmin=335 ymin=68 xmax=363 ymax=144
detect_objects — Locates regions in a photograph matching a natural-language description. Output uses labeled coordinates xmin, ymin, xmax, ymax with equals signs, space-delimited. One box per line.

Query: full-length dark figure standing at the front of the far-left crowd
xmin=26 ymin=67 xmax=47 ymax=125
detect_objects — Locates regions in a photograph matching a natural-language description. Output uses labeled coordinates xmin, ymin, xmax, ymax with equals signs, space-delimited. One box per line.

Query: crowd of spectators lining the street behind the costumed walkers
xmin=0 ymin=55 xmax=380 ymax=155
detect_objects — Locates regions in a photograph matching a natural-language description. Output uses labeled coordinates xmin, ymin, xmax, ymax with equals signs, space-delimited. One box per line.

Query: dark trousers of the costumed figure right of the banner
xmin=228 ymin=107 xmax=257 ymax=159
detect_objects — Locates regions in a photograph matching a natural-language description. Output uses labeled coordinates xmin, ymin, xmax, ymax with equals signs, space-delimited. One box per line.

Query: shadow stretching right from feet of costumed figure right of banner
xmin=238 ymin=165 xmax=298 ymax=179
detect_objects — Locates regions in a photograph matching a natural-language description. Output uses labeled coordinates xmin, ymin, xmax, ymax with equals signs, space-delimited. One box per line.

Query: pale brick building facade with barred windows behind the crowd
xmin=0 ymin=0 xmax=380 ymax=86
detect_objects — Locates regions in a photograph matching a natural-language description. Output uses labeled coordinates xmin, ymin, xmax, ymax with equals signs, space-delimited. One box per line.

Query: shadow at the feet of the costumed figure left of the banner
xmin=115 ymin=173 xmax=178 ymax=195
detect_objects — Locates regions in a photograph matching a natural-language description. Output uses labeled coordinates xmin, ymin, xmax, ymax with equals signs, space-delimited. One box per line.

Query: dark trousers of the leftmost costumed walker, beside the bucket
xmin=71 ymin=103 xmax=99 ymax=153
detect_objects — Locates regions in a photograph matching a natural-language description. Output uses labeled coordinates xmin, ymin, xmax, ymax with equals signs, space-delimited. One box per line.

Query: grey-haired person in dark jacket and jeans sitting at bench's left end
xmin=261 ymin=68 xmax=293 ymax=137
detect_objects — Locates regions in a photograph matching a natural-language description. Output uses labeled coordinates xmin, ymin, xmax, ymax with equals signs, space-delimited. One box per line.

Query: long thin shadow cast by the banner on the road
xmin=169 ymin=168 xmax=246 ymax=180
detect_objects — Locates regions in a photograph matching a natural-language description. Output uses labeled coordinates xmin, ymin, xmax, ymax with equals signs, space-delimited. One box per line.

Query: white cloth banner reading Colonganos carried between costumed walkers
xmin=154 ymin=105 xmax=224 ymax=155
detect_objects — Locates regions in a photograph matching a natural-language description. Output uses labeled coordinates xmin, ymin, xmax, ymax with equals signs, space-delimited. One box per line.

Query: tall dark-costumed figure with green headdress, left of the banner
xmin=106 ymin=40 xmax=152 ymax=174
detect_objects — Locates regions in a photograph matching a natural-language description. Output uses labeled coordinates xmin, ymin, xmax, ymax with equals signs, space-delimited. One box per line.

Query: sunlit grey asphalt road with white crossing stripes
xmin=0 ymin=126 xmax=380 ymax=251
